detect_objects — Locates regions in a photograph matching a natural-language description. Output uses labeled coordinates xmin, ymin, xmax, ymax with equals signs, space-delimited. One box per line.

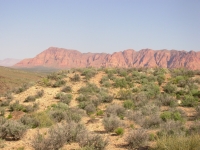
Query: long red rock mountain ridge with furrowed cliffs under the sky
xmin=14 ymin=47 xmax=200 ymax=70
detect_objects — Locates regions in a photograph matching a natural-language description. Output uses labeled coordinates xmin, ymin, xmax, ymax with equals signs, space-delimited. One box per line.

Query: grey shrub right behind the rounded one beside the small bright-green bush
xmin=106 ymin=103 xmax=125 ymax=117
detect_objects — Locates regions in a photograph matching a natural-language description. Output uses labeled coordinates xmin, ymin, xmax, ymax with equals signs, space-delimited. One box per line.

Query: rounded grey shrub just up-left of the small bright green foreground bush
xmin=103 ymin=115 xmax=123 ymax=132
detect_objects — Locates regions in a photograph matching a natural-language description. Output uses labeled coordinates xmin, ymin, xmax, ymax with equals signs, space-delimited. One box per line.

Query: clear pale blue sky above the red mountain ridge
xmin=0 ymin=0 xmax=200 ymax=60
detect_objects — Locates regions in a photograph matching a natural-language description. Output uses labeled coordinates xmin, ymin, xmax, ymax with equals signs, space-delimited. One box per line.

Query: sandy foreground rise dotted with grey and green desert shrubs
xmin=0 ymin=68 xmax=200 ymax=150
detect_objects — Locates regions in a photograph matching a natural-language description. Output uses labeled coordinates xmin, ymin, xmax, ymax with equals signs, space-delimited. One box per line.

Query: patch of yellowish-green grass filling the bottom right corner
xmin=155 ymin=134 xmax=200 ymax=150
